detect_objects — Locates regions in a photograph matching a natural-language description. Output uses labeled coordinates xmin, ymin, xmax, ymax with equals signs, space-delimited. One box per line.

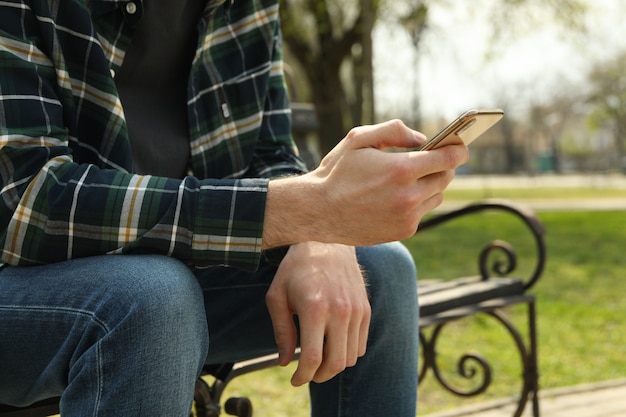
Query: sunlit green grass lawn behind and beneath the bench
xmin=213 ymin=206 xmax=626 ymax=417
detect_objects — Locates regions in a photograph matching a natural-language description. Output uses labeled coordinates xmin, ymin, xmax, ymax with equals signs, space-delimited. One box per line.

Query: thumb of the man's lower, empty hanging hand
xmin=266 ymin=291 xmax=297 ymax=366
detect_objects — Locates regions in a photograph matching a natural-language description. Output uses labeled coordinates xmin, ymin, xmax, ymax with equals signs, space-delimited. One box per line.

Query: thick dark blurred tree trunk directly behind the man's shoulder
xmin=281 ymin=0 xmax=379 ymax=153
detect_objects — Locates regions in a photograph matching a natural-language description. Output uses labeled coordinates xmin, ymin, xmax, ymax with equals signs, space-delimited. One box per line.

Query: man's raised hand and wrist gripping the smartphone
xmin=263 ymin=121 xmax=468 ymax=248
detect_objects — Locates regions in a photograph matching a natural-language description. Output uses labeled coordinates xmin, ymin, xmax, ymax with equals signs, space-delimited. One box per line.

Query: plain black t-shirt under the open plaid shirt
xmin=115 ymin=0 xmax=206 ymax=178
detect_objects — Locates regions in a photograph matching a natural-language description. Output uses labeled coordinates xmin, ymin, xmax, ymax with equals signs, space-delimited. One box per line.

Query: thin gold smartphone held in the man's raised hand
xmin=417 ymin=109 xmax=504 ymax=151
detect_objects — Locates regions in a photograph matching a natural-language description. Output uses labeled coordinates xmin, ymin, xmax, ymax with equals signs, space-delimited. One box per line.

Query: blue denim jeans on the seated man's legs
xmin=0 ymin=243 xmax=418 ymax=417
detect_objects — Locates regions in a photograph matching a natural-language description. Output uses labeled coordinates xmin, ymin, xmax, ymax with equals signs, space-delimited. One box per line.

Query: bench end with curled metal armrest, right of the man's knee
xmin=418 ymin=200 xmax=546 ymax=417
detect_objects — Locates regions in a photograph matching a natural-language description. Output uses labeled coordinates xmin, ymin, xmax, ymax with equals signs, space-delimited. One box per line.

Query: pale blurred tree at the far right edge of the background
xmin=589 ymin=51 xmax=626 ymax=172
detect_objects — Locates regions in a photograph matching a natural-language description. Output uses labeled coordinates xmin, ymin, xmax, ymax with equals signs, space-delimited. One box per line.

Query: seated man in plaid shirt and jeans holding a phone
xmin=0 ymin=0 xmax=467 ymax=417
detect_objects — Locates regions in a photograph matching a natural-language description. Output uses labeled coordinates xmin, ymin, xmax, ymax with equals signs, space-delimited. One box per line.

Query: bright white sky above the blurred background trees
xmin=374 ymin=0 xmax=626 ymax=123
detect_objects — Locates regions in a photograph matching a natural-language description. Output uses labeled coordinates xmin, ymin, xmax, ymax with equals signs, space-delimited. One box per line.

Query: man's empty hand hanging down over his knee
xmin=266 ymin=242 xmax=371 ymax=386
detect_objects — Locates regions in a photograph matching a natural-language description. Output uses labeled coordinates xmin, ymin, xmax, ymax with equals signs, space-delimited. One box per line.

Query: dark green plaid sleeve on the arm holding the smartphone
xmin=0 ymin=0 xmax=268 ymax=270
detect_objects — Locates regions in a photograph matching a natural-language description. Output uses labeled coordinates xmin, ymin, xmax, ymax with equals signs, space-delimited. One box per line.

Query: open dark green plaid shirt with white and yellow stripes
xmin=0 ymin=0 xmax=305 ymax=269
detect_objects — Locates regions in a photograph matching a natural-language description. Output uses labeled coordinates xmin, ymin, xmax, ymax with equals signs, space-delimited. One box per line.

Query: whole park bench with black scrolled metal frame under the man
xmin=0 ymin=200 xmax=546 ymax=417
